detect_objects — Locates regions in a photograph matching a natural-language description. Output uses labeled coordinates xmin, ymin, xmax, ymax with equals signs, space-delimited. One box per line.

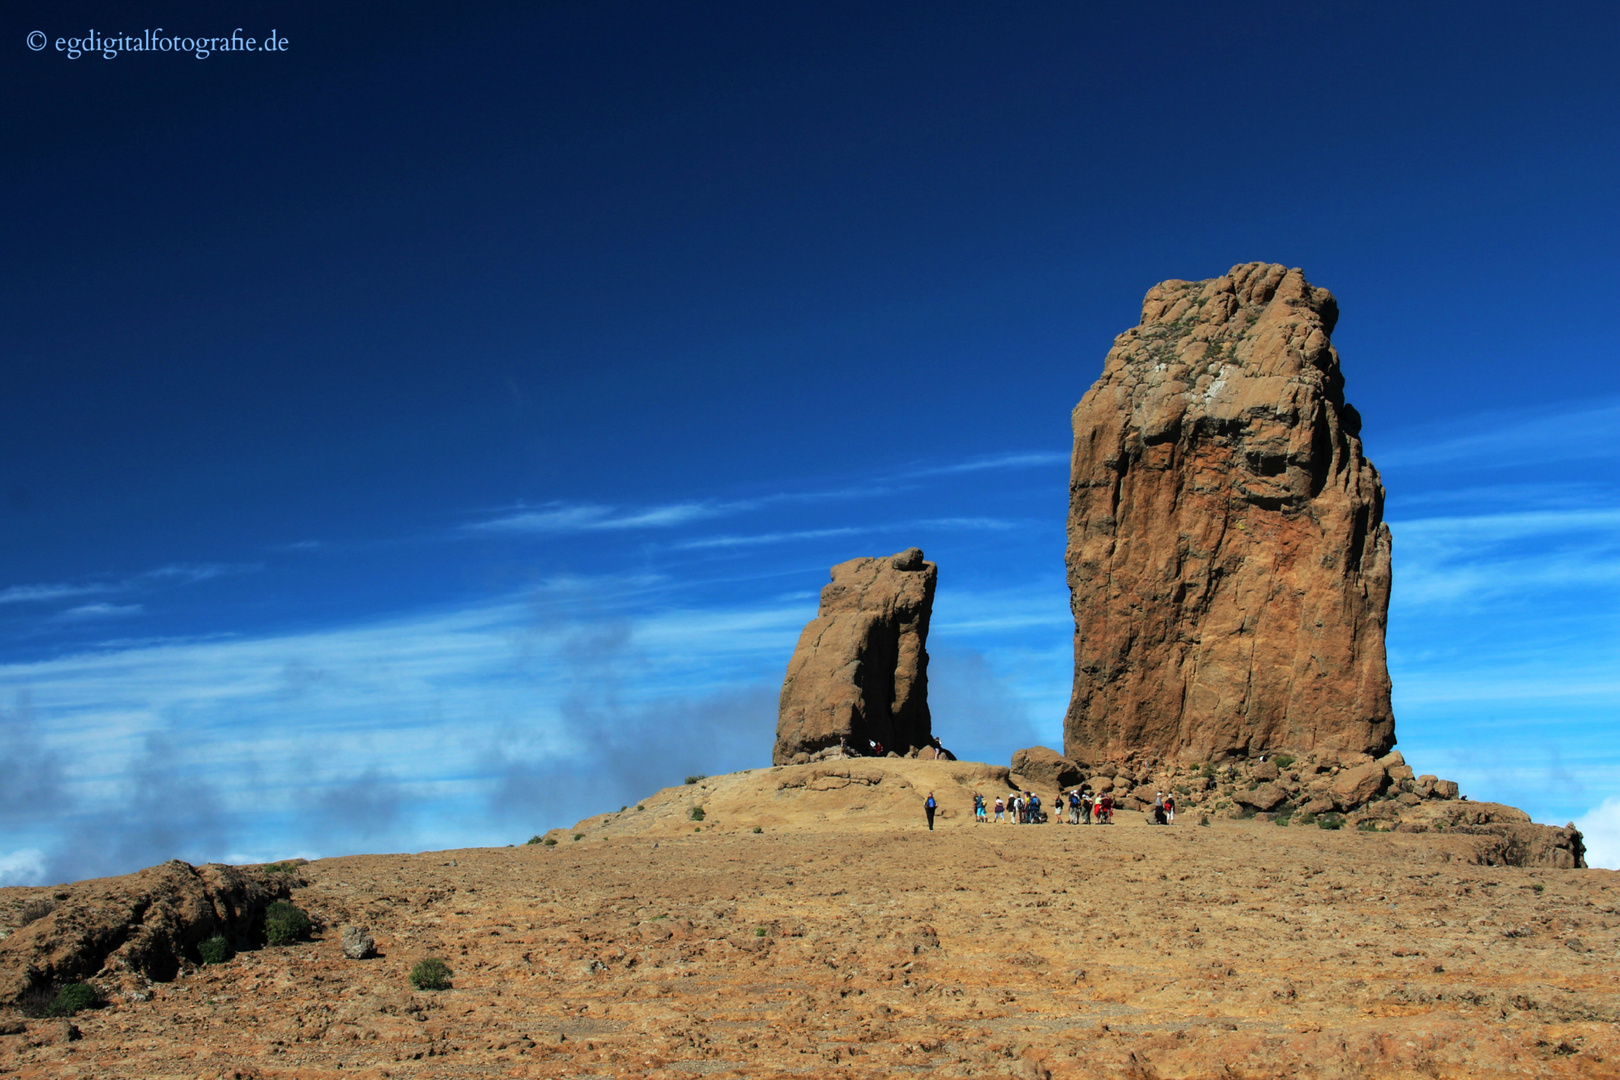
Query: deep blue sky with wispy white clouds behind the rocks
xmin=0 ymin=3 xmax=1620 ymax=882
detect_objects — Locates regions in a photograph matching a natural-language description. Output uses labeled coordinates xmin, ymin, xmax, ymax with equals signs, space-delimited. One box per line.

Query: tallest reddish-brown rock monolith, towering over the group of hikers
xmin=1064 ymin=262 xmax=1395 ymax=763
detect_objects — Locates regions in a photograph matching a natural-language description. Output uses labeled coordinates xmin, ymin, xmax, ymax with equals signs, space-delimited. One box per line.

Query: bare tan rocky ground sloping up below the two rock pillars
xmin=0 ymin=761 xmax=1620 ymax=1080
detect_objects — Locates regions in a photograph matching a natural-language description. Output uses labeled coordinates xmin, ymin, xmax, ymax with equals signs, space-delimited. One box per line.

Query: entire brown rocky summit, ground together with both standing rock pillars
xmin=0 ymin=262 xmax=1600 ymax=1080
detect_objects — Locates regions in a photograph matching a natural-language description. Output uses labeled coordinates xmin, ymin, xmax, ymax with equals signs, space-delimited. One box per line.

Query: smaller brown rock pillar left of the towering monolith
xmin=771 ymin=547 xmax=938 ymax=764
